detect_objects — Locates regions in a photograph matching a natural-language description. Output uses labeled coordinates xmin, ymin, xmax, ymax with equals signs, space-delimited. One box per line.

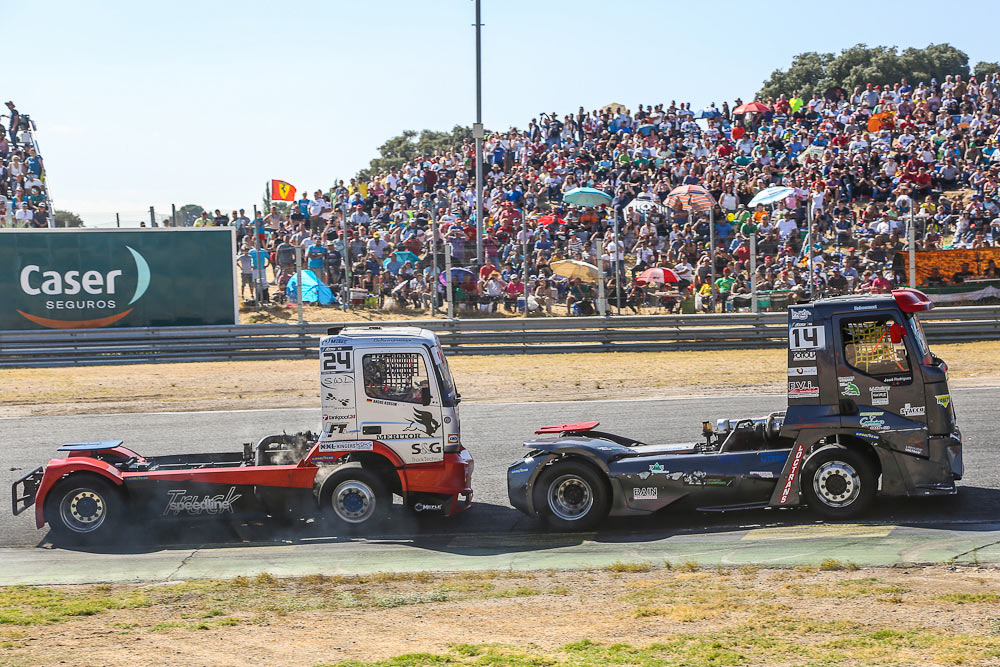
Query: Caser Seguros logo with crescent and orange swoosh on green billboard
xmin=17 ymin=246 xmax=150 ymax=329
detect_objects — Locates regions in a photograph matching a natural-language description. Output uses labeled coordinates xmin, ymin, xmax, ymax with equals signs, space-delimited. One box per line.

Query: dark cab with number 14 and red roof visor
xmin=781 ymin=289 xmax=964 ymax=502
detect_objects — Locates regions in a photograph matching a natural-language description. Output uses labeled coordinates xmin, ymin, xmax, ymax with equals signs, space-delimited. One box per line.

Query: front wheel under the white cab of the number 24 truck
xmin=319 ymin=462 xmax=392 ymax=530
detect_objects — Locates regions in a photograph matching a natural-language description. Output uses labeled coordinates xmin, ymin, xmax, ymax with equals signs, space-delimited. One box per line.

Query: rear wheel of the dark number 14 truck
xmin=533 ymin=459 xmax=611 ymax=530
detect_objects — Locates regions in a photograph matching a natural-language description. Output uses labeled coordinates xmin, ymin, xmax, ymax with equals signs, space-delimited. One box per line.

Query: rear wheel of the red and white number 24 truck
xmin=44 ymin=473 xmax=124 ymax=545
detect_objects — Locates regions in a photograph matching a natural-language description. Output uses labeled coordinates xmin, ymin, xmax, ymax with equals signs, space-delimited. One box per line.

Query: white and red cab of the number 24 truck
xmin=320 ymin=326 xmax=473 ymax=515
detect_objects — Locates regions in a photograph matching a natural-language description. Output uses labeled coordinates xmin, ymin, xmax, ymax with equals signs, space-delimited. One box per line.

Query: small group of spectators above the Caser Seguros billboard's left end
xmin=0 ymin=102 xmax=49 ymax=227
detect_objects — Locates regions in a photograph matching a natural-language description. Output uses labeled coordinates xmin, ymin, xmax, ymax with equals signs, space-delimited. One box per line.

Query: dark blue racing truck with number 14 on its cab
xmin=507 ymin=289 xmax=963 ymax=530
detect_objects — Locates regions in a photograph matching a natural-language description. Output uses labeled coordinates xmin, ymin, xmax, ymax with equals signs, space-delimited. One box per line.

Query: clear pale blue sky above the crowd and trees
xmin=0 ymin=0 xmax=1000 ymax=224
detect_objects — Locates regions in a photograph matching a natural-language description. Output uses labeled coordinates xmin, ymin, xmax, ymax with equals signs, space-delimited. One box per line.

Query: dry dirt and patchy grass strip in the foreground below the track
xmin=0 ymin=561 xmax=1000 ymax=667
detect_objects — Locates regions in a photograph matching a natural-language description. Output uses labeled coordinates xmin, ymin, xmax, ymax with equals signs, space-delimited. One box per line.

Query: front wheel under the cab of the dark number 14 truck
xmin=802 ymin=447 xmax=877 ymax=519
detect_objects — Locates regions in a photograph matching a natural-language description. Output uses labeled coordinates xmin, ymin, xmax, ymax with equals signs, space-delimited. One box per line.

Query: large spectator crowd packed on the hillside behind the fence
xmin=195 ymin=75 xmax=1000 ymax=314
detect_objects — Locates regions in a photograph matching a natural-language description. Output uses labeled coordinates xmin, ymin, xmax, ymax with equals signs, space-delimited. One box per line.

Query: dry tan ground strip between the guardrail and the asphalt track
xmin=0 ymin=342 xmax=1000 ymax=417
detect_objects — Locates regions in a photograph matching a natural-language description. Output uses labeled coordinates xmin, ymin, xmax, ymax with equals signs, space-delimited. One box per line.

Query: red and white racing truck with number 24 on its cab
xmin=11 ymin=327 xmax=473 ymax=543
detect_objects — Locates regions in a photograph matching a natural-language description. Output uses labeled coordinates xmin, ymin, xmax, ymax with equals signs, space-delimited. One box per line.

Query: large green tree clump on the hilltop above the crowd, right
xmin=757 ymin=44 xmax=968 ymax=98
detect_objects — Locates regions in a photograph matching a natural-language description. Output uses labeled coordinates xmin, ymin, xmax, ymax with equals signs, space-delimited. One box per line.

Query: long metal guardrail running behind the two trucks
xmin=0 ymin=306 xmax=1000 ymax=368
